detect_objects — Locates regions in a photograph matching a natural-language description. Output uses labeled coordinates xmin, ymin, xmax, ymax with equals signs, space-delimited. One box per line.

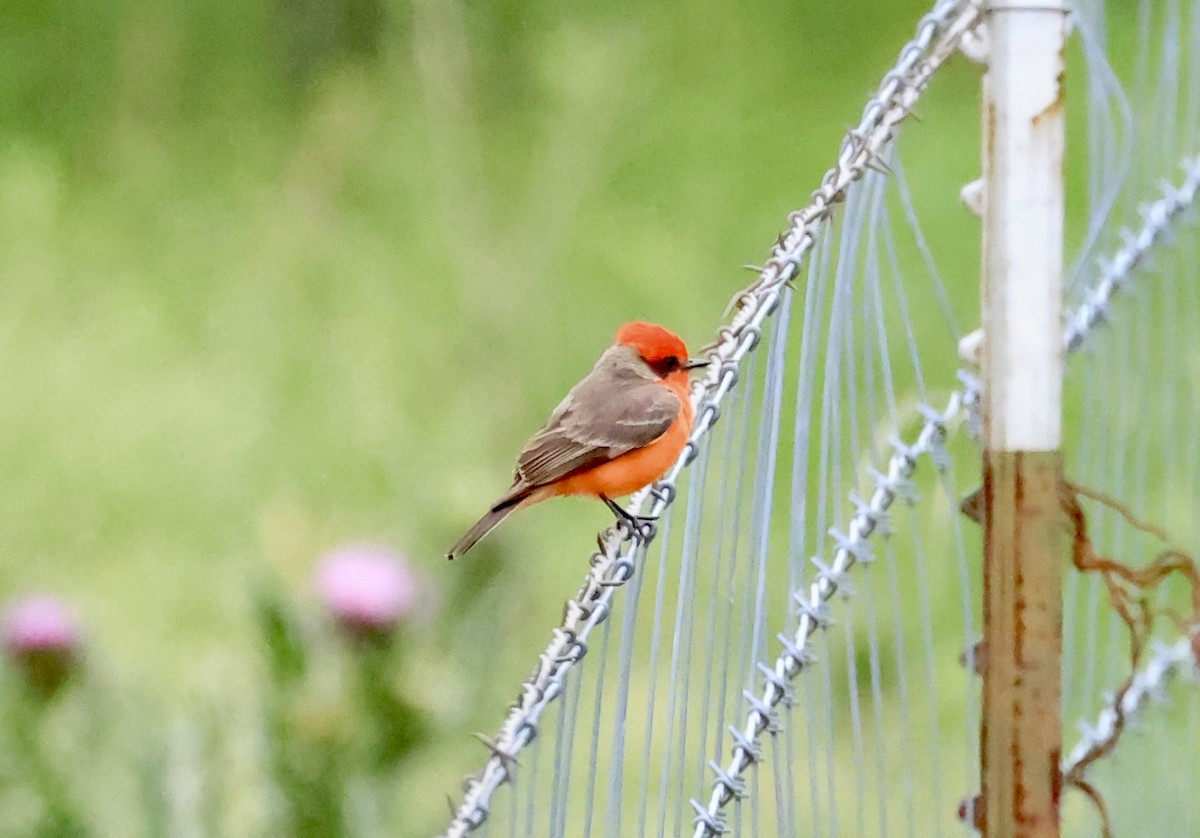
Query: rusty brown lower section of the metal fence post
xmin=982 ymin=451 xmax=1063 ymax=838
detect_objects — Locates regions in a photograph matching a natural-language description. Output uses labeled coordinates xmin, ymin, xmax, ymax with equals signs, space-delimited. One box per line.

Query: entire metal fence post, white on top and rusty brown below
xmin=978 ymin=0 xmax=1067 ymax=838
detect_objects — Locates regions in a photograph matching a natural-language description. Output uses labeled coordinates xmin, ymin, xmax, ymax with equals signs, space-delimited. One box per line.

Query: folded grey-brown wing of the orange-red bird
xmin=514 ymin=369 xmax=683 ymax=489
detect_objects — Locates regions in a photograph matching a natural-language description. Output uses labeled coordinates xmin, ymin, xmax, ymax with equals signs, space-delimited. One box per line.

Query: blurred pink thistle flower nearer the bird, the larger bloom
xmin=317 ymin=545 xmax=421 ymax=636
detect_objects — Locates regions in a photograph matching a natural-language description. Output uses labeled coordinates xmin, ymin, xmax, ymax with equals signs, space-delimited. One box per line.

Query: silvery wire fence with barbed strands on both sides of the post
xmin=445 ymin=0 xmax=1200 ymax=838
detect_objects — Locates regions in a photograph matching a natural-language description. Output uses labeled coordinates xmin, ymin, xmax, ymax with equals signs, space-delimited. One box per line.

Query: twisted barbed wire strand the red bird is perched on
xmin=443 ymin=0 xmax=980 ymax=838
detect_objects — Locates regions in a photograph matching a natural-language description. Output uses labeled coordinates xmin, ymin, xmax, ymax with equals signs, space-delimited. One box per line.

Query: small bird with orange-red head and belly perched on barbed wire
xmin=446 ymin=321 xmax=708 ymax=559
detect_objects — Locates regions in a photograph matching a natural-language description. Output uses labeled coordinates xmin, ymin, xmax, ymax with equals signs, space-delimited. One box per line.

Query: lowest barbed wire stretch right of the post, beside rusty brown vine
xmin=1060 ymin=634 xmax=1200 ymax=776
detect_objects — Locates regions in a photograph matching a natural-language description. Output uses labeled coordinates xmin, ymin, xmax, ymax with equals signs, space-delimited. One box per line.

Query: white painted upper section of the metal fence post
xmin=983 ymin=0 xmax=1067 ymax=451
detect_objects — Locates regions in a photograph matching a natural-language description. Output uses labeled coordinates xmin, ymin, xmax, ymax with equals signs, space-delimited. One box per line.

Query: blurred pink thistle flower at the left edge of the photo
xmin=4 ymin=594 xmax=79 ymax=696
